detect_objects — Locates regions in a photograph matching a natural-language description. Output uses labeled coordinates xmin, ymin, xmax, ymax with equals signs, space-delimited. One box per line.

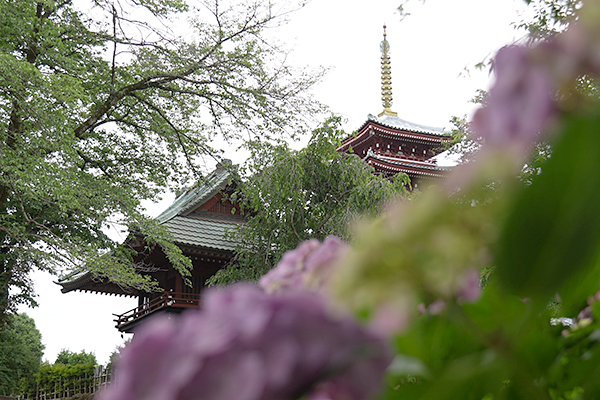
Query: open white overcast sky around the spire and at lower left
xmin=20 ymin=0 xmax=524 ymax=363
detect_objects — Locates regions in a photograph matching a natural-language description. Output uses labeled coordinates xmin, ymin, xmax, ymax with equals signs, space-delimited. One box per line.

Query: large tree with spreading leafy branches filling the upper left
xmin=0 ymin=0 xmax=320 ymax=315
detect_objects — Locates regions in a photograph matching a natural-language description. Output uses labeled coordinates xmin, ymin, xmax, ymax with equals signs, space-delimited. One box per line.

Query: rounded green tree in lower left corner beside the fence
xmin=0 ymin=313 xmax=44 ymax=396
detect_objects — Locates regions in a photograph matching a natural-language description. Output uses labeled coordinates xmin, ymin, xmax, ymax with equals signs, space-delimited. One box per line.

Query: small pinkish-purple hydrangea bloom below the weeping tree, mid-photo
xmin=260 ymin=236 xmax=350 ymax=293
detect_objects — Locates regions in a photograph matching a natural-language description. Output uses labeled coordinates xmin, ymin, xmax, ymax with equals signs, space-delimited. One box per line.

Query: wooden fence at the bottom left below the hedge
xmin=19 ymin=367 xmax=111 ymax=400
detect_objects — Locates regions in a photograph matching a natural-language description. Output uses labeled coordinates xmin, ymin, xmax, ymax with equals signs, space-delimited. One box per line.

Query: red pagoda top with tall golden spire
xmin=338 ymin=25 xmax=452 ymax=188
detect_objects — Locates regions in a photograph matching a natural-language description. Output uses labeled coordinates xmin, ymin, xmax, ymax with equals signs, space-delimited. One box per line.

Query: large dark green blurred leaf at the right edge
xmin=497 ymin=108 xmax=600 ymax=307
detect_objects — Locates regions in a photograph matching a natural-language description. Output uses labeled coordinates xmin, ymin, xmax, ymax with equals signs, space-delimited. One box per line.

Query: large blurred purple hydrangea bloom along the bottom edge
xmin=100 ymin=285 xmax=391 ymax=400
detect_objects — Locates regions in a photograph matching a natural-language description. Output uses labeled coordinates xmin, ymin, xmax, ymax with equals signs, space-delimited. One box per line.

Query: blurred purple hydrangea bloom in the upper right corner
xmin=472 ymin=0 xmax=600 ymax=165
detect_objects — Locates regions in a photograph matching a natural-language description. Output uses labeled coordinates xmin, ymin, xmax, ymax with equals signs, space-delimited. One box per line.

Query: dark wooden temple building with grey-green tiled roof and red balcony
xmin=58 ymin=160 xmax=244 ymax=332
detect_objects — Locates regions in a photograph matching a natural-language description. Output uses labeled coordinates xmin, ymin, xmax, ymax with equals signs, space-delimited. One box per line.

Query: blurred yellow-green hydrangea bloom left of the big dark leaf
xmin=332 ymin=188 xmax=492 ymax=334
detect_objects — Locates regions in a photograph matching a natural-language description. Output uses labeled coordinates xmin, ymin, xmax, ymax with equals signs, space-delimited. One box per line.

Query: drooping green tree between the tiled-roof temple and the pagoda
xmin=209 ymin=118 xmax=409 ymax=284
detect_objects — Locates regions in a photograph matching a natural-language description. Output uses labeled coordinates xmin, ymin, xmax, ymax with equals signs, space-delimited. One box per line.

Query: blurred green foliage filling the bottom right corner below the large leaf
xmin=379 ymin=287 xmax=600 ymax=400
